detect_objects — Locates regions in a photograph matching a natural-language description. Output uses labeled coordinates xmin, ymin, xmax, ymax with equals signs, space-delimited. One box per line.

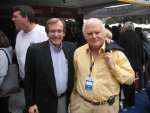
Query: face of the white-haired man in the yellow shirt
xmin=84 ymin=22 xmax=105 ymax=49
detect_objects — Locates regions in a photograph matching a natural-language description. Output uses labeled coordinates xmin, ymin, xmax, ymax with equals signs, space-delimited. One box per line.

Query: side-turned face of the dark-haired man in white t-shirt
xmin=12 ymin=11 xmax=27 ymax=30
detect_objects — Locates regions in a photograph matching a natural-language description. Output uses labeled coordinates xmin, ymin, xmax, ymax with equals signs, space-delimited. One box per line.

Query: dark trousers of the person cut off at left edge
xmin=0 ymin=97 xmax=9 ymax=113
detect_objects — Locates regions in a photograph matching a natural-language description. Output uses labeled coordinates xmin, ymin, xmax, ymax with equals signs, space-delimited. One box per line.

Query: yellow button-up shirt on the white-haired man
xmin=74 ymin=43 xmax=135 ymax=102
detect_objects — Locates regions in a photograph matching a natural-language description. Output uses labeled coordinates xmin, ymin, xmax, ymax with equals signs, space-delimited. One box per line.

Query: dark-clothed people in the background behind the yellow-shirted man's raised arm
xmin=106 ymin=22 xmax=150 ymax=110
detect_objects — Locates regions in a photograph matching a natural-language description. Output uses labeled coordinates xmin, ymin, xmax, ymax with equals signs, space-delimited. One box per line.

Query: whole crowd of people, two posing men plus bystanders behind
xmin=0 ymin=5 xmax=149 ymax=113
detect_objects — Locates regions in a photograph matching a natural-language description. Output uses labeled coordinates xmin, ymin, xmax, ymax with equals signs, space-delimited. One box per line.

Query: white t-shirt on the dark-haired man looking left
xmin=15 ymin=24 xmax=48 ymax=79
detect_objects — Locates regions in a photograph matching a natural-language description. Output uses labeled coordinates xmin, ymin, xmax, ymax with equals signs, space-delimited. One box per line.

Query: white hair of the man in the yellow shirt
xmin=82 ymin=18 xmax=105 ymax=35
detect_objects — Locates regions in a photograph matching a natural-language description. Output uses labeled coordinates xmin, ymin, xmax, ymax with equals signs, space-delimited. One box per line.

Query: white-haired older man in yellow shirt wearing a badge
xmin=70 ymin=18 xmax=135 ymax=113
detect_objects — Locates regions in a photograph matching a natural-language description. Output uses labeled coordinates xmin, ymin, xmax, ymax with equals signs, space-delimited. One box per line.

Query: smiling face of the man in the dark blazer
xmin=47 ymin=21 xmax=65 ymax=47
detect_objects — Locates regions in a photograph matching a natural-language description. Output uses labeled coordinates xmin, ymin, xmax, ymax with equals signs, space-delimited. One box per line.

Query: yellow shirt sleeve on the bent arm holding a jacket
xmin=111 ymin=51 xmax=135 ymax=85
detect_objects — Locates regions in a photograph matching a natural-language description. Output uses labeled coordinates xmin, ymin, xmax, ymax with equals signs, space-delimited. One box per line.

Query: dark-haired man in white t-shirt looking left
xmin=12 ymin=5 xmax=48 ymax=80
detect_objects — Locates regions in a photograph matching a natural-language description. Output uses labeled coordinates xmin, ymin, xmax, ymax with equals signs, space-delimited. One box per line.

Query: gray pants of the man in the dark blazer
xmin=57 ymin=95 xmax=67 ymax=113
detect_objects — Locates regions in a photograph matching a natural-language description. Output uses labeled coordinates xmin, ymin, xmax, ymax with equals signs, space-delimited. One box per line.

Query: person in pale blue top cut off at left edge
xmin=0 ymin=31 xmax=12 ymax=113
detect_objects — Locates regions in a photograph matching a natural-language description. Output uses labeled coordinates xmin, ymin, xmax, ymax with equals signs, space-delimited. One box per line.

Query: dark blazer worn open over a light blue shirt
xmin=25 ymin=41 xmax=75 ymax=113
